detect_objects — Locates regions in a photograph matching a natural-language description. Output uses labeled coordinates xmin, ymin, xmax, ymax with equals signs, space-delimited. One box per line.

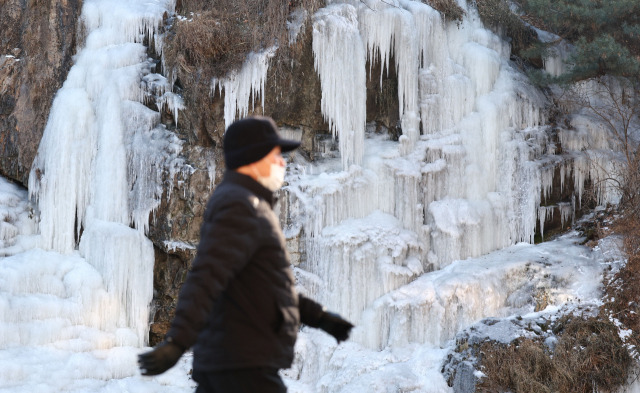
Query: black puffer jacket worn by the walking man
xmin=167 ymin=171 xmax=322 ymax=372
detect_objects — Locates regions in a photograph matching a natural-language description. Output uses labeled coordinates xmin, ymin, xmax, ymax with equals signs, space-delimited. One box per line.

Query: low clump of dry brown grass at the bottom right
xmin=477 ymin=315 xmax=632 ymax=393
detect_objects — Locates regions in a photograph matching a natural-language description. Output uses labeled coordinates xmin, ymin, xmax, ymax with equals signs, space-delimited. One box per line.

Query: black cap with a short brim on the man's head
xmin=223 ymin=116 xmax=300 ymax=169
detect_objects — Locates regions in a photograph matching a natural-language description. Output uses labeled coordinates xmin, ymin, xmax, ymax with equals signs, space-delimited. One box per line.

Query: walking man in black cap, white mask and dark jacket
xmin=139 ymin=117 xmax=353 ymax=393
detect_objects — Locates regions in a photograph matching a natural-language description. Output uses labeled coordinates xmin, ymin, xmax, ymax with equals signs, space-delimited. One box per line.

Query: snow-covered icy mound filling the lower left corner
xmin=0 ymin=178 xmax=194 ymax=393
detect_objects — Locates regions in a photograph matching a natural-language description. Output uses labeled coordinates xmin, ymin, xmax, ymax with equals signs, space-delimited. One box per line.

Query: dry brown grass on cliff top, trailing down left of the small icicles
xmin=162 ymin=0 xmax=323 ymax=142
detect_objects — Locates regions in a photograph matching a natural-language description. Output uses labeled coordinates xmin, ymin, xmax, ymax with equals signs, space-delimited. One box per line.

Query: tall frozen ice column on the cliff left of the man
xmin=29 ymin=0 xmax=176 ymax=345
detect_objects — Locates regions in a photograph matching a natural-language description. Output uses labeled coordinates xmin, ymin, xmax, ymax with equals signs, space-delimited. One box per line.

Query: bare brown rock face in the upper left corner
xmin=0 ymin=0 xmax=82 ymax=184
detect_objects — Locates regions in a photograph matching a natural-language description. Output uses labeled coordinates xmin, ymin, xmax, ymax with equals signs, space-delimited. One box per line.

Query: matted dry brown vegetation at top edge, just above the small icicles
xmin=164 ymin=0 xmax=320 ymax=79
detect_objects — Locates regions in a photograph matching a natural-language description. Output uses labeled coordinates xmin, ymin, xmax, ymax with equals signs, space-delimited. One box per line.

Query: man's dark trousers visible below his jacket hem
xmin=193 ymin=367 xmax=287 ymax=393
